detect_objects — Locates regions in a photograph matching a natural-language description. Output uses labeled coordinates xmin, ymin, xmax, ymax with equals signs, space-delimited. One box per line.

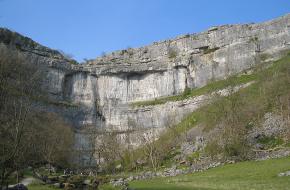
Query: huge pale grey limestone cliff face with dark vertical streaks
xmin=0 ymin=14 xmax=290 ymax=163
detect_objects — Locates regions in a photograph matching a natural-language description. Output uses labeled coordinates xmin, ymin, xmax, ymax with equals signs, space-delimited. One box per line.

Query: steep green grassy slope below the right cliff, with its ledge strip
xmin=125 ymin=52 xmax=290 ymax=171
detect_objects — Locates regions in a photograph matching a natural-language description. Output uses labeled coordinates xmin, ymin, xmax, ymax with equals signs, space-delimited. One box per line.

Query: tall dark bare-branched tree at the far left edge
xmin=0 ymin=47 xmax=41 ymax=187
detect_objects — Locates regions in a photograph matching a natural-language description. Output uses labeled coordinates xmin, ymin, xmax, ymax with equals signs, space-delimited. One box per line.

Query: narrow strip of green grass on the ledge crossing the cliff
xmin=131 ymin=74 xmax=257 ymax=107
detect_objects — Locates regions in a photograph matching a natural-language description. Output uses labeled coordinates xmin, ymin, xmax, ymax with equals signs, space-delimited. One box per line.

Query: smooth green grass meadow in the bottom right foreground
xmin=130 ymin=158 xmax=290 ymax=190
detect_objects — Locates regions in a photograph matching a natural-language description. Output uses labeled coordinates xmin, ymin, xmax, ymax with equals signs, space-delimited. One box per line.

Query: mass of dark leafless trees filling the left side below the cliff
xmin=0 ymin=46 xmax=72 ymax=187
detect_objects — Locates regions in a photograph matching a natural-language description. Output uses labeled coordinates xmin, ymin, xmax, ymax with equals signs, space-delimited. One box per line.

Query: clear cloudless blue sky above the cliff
xmin=0 ymin=0 xmax=290 ymax=61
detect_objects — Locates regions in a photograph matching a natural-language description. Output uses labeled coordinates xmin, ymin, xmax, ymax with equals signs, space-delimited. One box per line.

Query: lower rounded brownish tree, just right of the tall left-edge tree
xmin=29 ymin=112 xmax=73 ymax=167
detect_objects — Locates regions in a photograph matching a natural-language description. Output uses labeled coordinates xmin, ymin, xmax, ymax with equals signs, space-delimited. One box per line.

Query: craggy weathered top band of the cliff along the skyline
xmin=0 ymin=14 xmax=290 ymax=68
